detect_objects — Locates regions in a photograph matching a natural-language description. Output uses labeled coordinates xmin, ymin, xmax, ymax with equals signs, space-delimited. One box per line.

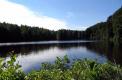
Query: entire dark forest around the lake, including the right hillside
xmin=0 ymin=7 xmax=122 ymax=43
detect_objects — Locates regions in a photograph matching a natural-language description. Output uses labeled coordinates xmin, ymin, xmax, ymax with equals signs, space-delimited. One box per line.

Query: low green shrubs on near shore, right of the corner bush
xmin=25 ymin=56 xmax=122 ymax=80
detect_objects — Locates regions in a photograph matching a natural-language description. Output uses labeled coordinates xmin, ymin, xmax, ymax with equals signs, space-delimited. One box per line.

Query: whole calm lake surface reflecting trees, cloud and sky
xmin=0 ymin=41 xmax=122 ymax=72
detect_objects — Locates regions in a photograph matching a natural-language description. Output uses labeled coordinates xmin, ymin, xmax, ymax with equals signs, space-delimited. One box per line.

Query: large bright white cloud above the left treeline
xmin=0 ymin=0 xmax=68 ymax=30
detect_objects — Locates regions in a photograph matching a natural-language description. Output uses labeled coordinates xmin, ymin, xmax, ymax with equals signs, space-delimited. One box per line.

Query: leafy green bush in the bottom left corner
xmin=0 ymin=55 xmax=25 ymax=80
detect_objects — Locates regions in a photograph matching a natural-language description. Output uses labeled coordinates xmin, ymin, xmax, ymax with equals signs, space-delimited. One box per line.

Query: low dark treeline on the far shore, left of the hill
xmin=0 ymin=22 xmax=85 ymax=42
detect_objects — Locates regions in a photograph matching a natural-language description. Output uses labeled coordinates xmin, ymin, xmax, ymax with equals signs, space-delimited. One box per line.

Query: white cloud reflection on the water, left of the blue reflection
xmin=17 ymin=47 xmax=66 ymax=71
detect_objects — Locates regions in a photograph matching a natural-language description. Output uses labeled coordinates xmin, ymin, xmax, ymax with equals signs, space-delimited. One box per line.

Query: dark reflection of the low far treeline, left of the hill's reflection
xmin=0 ymin=43 xmax=84 ymax=57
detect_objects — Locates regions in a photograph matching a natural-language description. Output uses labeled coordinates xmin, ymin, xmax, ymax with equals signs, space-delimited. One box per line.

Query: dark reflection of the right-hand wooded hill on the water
xmin=86 ymin=42 xmax=122 ymax=65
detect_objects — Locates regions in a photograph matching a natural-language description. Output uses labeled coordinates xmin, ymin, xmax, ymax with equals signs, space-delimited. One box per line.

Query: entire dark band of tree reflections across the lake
xmin=0 ymin=42 xmax=122 ymax=64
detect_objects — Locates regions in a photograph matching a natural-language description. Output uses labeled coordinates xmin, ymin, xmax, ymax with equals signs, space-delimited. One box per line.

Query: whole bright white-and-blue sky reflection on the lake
xmin=17 ymin=46 xmax=107 ymax=72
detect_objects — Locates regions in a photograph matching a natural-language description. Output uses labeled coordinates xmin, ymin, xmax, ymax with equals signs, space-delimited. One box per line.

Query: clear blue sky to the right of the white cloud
xmin=0 ymin=0 xmax=122 ymax=30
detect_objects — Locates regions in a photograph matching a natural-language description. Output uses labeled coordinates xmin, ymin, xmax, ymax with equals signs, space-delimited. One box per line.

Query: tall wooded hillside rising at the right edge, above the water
xmin=86 ymin=7 xmax=122 ymax=43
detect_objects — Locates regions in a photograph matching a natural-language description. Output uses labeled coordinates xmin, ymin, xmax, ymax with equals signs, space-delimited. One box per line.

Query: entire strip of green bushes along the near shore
xmin=0 ymin=56 xmax=122 ymax=80
